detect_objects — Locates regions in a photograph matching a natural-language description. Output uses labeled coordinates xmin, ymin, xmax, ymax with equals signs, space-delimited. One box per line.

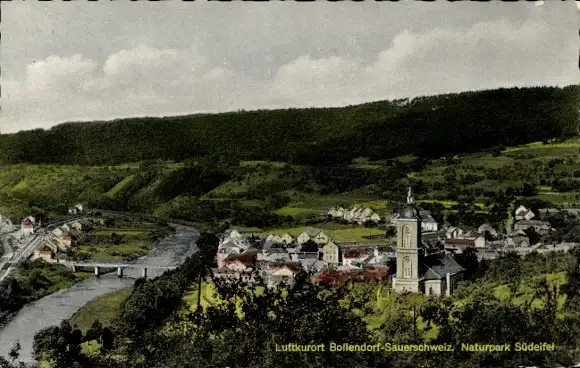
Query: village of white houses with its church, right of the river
xmin=213 ymin=189 xmax=575 ymax=295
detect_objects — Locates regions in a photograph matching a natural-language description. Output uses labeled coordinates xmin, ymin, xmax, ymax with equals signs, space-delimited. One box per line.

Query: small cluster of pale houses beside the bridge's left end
xmin=32 ymin=220 xmax=83 ymax=263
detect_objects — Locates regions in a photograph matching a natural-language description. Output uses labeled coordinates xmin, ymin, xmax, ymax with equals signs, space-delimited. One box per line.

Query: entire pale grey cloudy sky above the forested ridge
xmin=0 ymin=0 xmax=580 ymax=133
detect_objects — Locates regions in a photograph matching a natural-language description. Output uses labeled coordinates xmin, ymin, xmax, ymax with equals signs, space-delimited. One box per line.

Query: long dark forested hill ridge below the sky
xmin=0 ymin=86 xmax=580 ymax=164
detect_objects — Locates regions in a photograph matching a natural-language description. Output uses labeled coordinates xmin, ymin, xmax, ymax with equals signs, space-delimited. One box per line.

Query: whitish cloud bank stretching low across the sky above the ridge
xmin=0 ymin=6 xmax=578 ymax=131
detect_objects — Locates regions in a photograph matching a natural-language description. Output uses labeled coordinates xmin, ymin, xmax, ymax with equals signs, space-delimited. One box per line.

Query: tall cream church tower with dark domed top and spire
xmin=394 ymin=187 xmax=421 ymax=293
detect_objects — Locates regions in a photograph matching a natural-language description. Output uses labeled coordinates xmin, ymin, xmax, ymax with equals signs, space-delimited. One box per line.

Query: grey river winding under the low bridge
xmin=0 ymin=225 xmax=199 ymax=362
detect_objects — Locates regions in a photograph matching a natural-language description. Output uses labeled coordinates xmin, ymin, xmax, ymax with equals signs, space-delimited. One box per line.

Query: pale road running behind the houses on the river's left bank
xmin=0 ymin=214 xmax=89 ymax=282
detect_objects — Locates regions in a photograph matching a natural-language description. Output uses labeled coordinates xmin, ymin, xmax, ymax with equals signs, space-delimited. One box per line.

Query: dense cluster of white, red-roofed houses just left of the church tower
xmin=213 ymin=227 xmax=395 ymax=287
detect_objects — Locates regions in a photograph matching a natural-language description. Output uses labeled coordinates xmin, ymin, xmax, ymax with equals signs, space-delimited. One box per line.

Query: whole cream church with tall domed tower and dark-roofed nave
xmin=392 ymin=188 xmax=464 ymax=296
